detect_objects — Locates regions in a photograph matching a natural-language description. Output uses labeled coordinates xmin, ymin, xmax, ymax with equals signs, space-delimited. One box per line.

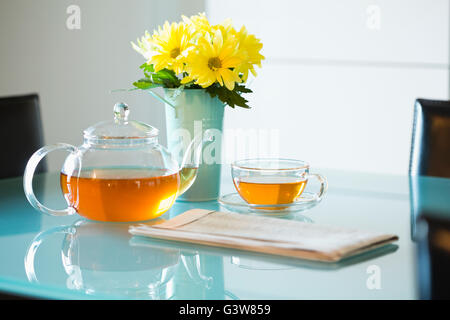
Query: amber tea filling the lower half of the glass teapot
xmin=61 ymin=168 xmax=180 ymax=221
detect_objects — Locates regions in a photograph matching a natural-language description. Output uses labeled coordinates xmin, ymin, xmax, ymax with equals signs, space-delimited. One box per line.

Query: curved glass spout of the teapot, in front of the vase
xmin=178 ymin=130 xmax=212 ymax=195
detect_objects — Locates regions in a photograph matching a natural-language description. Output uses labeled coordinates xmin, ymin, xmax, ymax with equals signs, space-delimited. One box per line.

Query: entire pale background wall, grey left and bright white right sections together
xmin=0 ymin=0 xmax=450 ymax=174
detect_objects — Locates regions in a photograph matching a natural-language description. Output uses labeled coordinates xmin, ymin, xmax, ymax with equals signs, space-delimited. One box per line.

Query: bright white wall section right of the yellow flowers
xmin=206 ymin=0 xmax=450 ymax=174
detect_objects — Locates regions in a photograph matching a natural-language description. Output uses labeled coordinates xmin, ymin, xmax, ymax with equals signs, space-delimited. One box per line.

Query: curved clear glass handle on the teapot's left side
xmin=23 ymin=143 xmax=78 ymax=216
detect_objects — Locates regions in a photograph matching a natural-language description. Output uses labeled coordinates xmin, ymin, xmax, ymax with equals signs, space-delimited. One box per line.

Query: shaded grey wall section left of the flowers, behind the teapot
xmin=0 ymin=0 xmax=204 ymax=170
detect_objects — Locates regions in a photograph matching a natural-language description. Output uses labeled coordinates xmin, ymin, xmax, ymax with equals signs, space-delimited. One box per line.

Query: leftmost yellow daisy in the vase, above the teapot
xmin=148 ymin=21 xmax=193 ymax=74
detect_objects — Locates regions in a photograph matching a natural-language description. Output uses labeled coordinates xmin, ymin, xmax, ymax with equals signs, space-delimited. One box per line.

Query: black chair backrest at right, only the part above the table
xmin=409 ymin=99 xmax=450 ymax=178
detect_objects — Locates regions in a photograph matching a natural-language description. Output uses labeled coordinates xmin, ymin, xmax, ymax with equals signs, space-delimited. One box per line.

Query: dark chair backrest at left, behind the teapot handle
xmin=0 ymin=94 xmax=47 ymax=179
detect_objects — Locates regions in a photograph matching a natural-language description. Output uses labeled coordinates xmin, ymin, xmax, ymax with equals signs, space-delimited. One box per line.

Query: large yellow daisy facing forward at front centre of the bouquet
xmin=182 ymin=29 xmax=242 ymax=90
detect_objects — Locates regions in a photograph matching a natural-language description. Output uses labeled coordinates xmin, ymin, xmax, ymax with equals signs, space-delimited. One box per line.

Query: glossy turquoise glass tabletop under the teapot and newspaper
xmin=0 ymin=170 xmax=450 ymax=299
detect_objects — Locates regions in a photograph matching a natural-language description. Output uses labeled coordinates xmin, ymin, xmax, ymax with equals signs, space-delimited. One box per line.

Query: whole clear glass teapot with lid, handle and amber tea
xmin=23 ymin=103 xmax=202 ymax=222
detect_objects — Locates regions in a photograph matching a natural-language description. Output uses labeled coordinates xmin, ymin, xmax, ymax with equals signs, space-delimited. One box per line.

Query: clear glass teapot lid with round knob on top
xmin=83 ymin=102 xmax=158 ymax=143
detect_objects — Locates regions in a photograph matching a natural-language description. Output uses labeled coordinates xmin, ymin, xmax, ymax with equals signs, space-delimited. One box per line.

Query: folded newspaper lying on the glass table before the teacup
xmin=129 ymin=209 xmax=398 ymax=262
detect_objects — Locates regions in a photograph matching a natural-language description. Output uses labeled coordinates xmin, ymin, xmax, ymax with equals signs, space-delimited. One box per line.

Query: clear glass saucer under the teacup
xmin=218 ymin=192 xmax=322 ymax=215
